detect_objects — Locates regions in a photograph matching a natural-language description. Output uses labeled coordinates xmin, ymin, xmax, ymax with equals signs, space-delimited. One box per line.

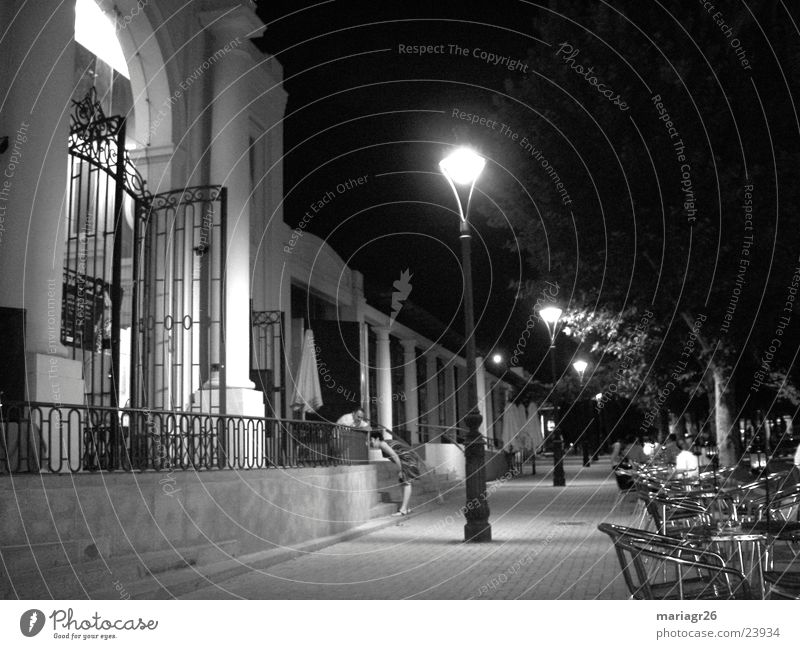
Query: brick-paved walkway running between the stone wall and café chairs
xmin=183 ymin=458 xmax=635 ymax=599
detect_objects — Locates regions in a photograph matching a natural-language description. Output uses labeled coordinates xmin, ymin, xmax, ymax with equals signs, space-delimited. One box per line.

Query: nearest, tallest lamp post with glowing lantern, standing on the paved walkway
xmin=439 ymin=149 xmax=492 ymax=543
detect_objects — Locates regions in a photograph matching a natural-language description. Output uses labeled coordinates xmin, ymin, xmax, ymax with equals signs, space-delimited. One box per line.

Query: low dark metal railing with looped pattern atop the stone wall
xmin=0 ymin=402 xmax=367 ymax=473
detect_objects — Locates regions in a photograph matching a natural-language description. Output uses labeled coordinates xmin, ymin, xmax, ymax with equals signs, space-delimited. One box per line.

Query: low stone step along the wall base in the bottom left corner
xmin=0 ymin=540 xmax=240 ymax=599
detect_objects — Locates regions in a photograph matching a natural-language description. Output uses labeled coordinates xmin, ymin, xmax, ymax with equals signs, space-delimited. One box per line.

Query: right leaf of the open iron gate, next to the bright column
xmin=132 ymin=185 xmax=227 ymax=413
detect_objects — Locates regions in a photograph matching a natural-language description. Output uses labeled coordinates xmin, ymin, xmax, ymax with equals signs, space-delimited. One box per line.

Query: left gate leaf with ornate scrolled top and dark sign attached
xmin=61 ymin=88 xmax=148 ymax=407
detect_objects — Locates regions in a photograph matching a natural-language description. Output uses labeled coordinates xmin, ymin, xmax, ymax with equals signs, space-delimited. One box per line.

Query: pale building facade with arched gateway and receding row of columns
xmin=0 ymin=0 xmax=536 ymax=471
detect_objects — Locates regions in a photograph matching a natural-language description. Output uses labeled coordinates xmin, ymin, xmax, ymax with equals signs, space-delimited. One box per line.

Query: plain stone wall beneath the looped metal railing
xmin=0 ymin=466 xmax=380 ymax=566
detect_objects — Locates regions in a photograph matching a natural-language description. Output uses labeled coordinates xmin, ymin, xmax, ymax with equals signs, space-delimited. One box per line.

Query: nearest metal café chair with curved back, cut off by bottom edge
xmin=598 ymin=523 xmax=752 ymax=600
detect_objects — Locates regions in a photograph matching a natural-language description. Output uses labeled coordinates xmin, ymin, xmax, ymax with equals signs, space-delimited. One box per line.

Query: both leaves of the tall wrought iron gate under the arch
xmin=61 ymin=88 xmax=226 ymax=416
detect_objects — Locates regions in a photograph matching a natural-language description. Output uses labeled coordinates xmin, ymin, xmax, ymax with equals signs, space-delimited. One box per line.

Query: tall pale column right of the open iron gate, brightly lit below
xmin=203 ymin=6 xmax=264 ymax=417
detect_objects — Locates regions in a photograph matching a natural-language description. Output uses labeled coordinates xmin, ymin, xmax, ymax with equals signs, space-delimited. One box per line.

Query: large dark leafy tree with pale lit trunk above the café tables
xmin=468 ymin=2 xmax=800 ymax=464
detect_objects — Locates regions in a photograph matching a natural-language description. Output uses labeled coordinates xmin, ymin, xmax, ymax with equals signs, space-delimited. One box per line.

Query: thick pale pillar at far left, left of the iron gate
xmin=0 ymin=2 xmax=84 ymax=403
